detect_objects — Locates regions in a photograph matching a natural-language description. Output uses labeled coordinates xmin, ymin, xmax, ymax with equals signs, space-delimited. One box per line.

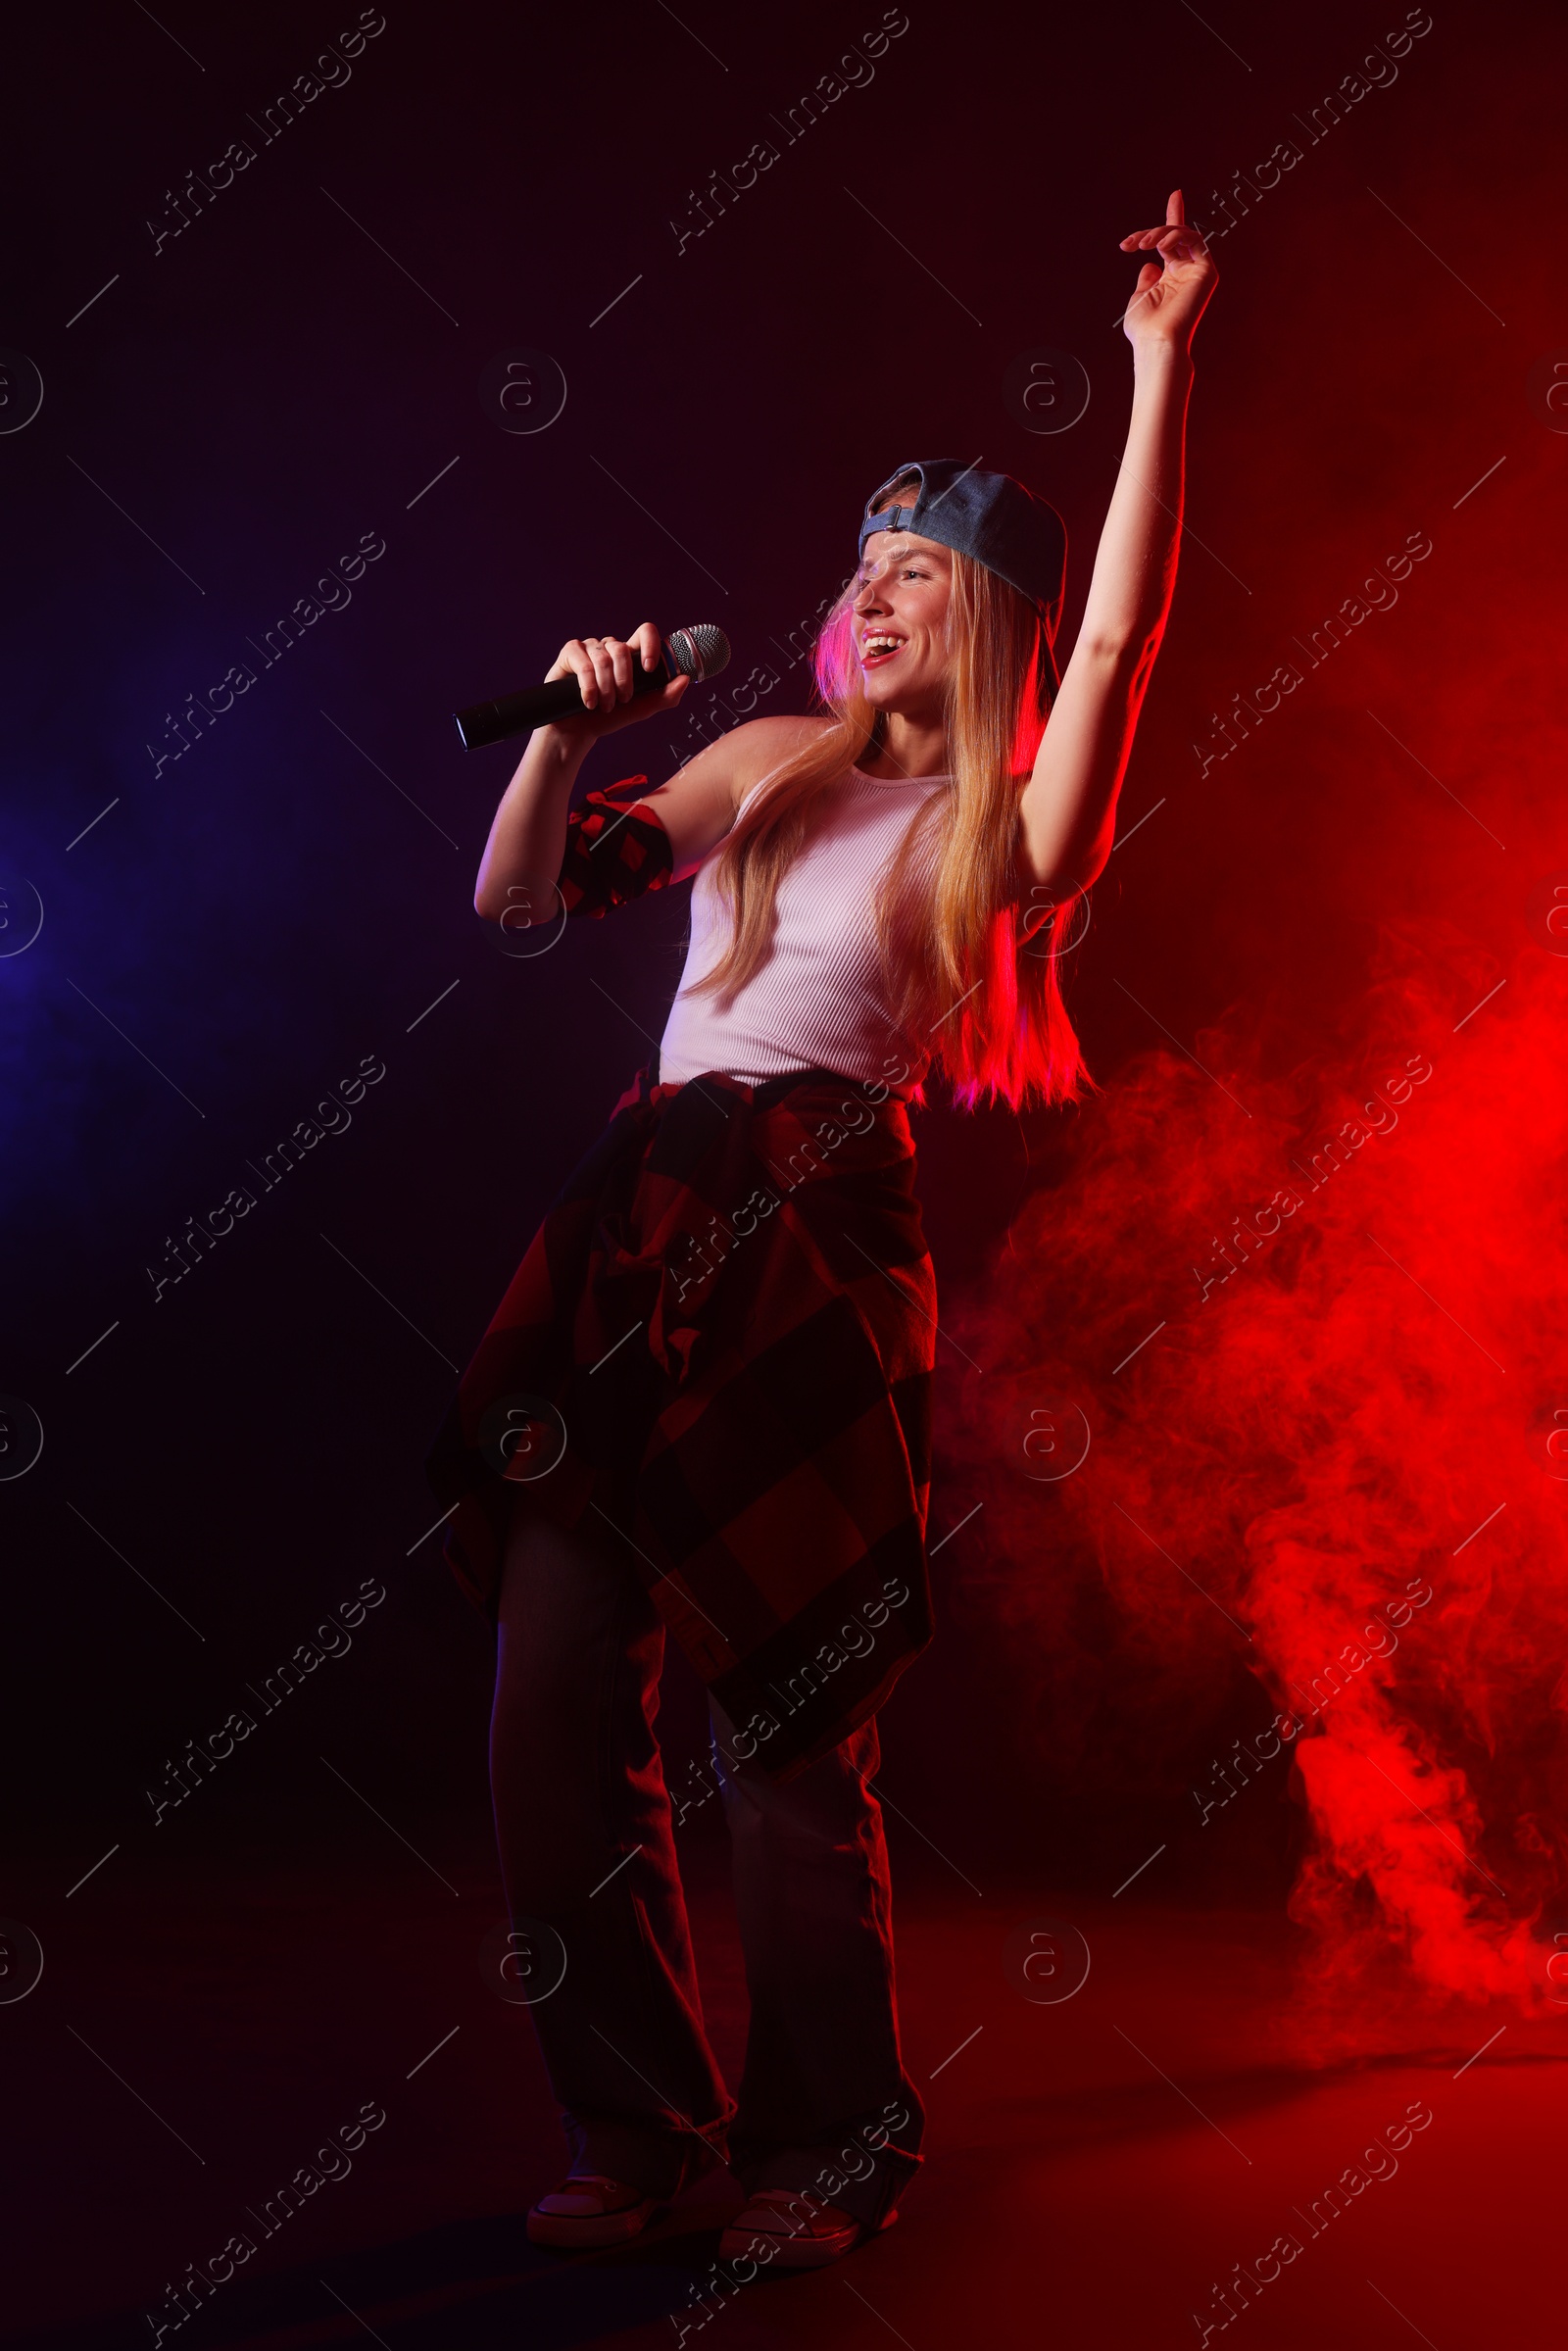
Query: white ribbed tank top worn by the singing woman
xmin=659 ymin=766 xmax=950 ymax=1094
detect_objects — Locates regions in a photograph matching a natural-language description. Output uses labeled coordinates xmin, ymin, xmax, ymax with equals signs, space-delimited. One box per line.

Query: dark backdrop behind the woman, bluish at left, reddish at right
xmin=0 ymin=0 xmax=1568 ymax=2331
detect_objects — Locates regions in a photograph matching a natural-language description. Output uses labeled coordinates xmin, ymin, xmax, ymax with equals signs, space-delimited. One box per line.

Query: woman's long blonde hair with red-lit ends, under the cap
xmin=694 ymin=484 xmax=1093 ymax=1109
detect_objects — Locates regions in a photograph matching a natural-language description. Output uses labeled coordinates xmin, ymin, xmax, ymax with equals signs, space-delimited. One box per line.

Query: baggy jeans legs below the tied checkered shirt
xmin=491 ymin=1507 xmax=924 ymax=2227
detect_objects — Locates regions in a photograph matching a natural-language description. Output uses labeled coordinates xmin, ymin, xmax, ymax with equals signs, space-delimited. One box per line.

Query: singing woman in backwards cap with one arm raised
xmin=430 ymin=193 xmax=1215 ymax=2274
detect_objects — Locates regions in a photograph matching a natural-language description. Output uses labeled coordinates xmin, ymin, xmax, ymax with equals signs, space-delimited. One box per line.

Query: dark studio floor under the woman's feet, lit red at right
xmin=0 ymin=1832 xmax=1568 ymax=2351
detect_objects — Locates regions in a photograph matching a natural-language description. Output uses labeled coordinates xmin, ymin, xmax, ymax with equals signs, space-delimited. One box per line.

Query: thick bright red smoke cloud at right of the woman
xmin=964 ymin=929 xmax=1568 ymax=2015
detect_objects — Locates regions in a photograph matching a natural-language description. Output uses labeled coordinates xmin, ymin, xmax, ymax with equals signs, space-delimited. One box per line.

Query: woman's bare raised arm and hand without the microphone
xmin=1018 ymin=188 xmax=1218 ymax=903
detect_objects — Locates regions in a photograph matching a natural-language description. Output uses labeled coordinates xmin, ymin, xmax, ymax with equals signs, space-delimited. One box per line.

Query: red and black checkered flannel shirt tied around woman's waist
xmin=430 ymin=1070 xmax=936 ymax=1780
